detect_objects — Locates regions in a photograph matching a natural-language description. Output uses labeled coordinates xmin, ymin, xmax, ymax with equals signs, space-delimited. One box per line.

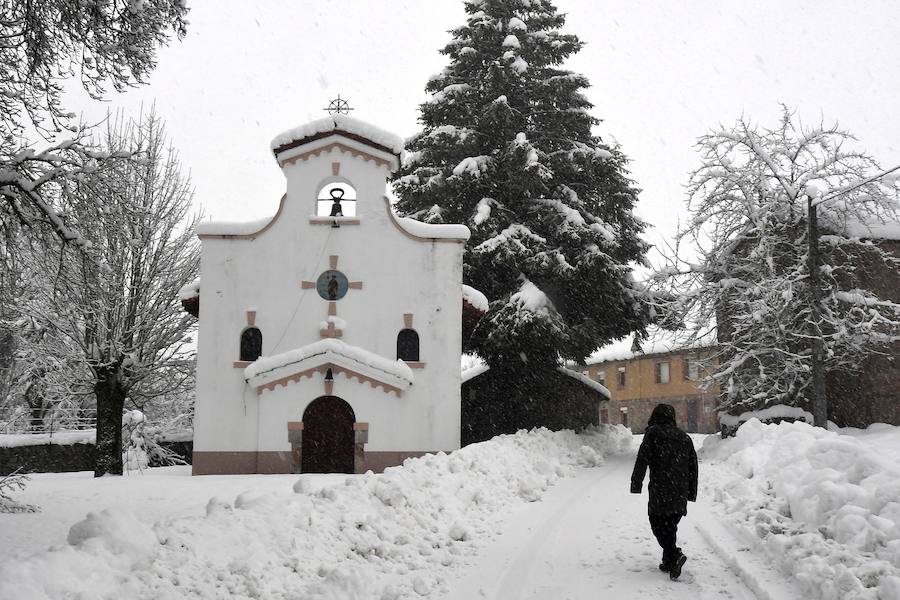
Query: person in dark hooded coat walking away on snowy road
xmin=631 ymin=404 xmax=697 ymax=579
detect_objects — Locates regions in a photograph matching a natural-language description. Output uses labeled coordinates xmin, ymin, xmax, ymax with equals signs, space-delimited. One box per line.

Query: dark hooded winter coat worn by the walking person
xmin=631 ymin=404 xmax=697 ymax=515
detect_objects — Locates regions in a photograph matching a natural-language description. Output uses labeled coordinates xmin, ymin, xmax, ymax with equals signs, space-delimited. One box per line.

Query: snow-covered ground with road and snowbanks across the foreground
xmin=0 ymin=421 xmax=900 ymax=600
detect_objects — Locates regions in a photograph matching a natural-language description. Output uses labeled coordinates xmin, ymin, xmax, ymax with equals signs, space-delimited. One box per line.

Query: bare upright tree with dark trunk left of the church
xmin=18 ymin=113 xmax=199 ymax=476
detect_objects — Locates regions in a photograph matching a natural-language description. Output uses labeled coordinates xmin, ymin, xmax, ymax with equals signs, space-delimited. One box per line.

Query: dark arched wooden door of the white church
xmin=300 ymin=396 xmax=356 ymax=473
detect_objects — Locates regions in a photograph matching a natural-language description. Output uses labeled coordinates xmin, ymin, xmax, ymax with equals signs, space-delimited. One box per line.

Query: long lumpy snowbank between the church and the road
xmin=0 ymin=425 xmax=631 ymax=600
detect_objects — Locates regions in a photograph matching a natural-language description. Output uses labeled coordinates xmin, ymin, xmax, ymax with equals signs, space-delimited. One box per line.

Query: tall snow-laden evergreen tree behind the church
xmin=395 ymin=0 xmax=647 ymax=367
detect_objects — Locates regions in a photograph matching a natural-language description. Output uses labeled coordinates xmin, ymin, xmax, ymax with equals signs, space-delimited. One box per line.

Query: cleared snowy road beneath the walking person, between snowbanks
xmin=443 ymin=456 xmax=800 ymax=600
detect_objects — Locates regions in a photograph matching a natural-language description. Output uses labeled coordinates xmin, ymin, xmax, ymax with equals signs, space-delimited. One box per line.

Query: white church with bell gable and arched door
xmin=182 ymin=114 xmax=469 ymax=475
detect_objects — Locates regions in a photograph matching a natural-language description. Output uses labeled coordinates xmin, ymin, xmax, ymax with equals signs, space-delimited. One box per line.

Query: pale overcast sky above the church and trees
xmin=70 ymin=0 xmax=900 ymax=262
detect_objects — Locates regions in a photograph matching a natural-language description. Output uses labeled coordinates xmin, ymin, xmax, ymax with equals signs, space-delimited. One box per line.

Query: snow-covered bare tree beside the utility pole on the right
xmin=656 ymin=108 xmax=900 ymax=425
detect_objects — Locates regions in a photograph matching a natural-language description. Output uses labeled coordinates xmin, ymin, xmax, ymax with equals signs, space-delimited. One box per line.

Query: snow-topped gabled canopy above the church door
xmin=244 ymin=339 xmax=413 ymax=388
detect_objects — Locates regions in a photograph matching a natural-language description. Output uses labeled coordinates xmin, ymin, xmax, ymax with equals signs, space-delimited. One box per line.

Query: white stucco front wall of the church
xmin=194 ymin=137 xmax=463 ymax=460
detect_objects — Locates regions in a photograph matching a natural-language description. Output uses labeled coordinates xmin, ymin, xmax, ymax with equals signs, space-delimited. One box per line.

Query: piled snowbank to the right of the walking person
xmin=701 ymin=419 xmax=900 ymax=600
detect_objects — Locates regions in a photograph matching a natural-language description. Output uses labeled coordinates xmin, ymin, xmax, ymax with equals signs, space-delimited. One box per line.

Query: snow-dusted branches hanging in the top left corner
xmin=0 ymin=0 xmax=187 ymax=244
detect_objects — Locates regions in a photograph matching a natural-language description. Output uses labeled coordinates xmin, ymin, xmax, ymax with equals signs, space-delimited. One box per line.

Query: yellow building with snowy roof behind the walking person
xmin=577 ymin=336 xmax=719 ymax=433
